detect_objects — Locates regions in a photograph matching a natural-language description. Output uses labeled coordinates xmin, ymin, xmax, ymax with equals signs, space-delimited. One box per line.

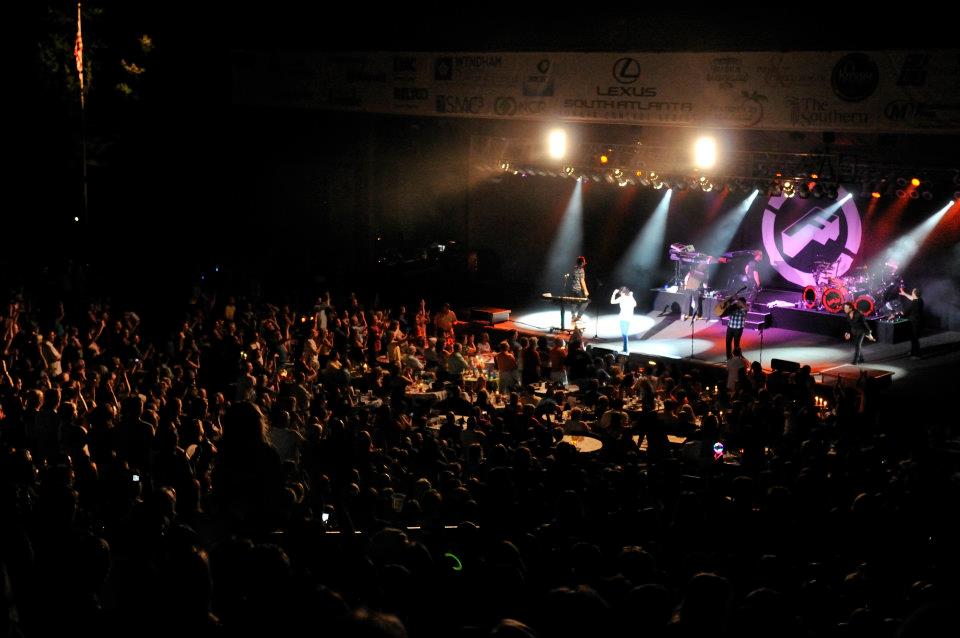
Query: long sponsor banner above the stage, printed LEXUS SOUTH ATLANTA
xmin=233 ymin=50 xmax=960 ymax=133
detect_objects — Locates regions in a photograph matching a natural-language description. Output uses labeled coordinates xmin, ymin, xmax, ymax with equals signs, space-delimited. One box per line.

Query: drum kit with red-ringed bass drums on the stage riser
xmin=801 ymin=260 xmax=903 ymax=317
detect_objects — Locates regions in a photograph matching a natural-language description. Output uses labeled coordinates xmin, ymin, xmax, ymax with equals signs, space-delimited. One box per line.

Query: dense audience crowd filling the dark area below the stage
xmin=0 ymin=290 xmax=960 ymax=638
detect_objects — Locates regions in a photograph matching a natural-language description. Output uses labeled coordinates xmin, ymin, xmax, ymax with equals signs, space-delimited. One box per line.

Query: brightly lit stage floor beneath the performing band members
xmin=495 ymin=309 xmax=960 ymax=400
